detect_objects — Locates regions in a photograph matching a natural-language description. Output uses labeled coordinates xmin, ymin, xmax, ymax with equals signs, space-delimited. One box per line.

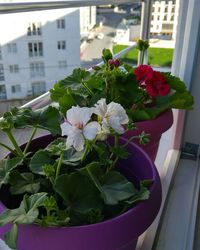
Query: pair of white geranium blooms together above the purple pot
xmin=61 ymin=99 xmax=128 ymax=151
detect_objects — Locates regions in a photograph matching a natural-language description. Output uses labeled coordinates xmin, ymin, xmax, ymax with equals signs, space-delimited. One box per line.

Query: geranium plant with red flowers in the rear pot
xmin=50 ymin=47 xmax=193 ymax=121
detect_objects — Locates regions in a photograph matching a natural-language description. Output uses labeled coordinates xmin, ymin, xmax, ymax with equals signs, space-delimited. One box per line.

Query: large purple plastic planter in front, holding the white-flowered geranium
xmin=0 ymin=136 xmax=162 ymax=250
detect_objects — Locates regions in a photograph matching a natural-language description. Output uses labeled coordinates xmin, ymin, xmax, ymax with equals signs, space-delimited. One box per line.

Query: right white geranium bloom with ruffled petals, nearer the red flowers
xmin=93 ymin=99 xmax=128 ymax=134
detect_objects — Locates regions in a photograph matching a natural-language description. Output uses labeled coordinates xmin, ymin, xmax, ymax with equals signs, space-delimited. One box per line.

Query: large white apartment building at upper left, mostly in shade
xmin=0 ymin=1 xmax=96 ymax=100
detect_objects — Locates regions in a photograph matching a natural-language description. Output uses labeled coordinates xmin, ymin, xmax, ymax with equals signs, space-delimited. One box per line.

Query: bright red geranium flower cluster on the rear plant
xmin=135 ymin=65 xmax=171 ymax=97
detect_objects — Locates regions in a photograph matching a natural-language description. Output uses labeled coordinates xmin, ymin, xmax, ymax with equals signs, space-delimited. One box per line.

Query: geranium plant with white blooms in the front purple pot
xmin=0 ymin=99 xmax=151 ymax=249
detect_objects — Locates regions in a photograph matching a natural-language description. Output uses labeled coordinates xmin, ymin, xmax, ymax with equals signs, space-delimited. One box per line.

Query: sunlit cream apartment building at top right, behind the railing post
xmin=150 ymin=0 xmax=179 ymax=40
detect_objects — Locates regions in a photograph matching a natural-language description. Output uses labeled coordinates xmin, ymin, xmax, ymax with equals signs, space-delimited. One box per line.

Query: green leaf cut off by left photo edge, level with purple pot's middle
xmin=0 ymin=157 xmax=23 ymax=188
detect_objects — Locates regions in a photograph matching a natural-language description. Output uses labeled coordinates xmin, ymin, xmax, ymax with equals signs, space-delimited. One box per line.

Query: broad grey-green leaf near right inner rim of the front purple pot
xmin=102 ymin=171 xmax=137 ymax=205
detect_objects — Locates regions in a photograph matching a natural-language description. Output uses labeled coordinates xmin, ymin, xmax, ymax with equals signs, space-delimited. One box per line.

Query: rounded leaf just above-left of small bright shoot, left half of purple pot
xmin=29 ymin=149 xmax=54 ymax=175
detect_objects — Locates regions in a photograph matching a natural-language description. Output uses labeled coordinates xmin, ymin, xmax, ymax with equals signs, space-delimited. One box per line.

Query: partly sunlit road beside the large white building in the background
xmin=81 ymin=12 xmax=126 ymax=68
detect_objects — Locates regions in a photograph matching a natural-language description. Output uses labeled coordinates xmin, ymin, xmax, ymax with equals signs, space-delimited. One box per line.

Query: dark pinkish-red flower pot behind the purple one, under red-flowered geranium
xmin=123 ymin=109 xmax=173 ymax=161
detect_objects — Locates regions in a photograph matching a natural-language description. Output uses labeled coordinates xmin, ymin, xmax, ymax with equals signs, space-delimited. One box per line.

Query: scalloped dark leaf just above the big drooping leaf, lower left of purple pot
xmin=9 ymin=170 xmax=40 ymax=194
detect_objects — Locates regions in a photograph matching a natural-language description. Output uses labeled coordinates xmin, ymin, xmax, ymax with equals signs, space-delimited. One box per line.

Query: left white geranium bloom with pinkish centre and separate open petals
xmin=61 ymin=107 xmax=101 ymax=151
